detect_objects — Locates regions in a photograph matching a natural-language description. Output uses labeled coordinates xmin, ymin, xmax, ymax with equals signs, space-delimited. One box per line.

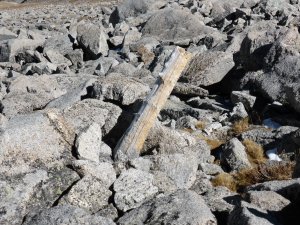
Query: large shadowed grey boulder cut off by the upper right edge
xmin=254 ymin=28 xmax=300 ymax=112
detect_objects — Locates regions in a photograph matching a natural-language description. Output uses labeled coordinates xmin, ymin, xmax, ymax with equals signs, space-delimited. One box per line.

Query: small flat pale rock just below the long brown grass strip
xmin=247 ymin=191 xmax=291 ymax=211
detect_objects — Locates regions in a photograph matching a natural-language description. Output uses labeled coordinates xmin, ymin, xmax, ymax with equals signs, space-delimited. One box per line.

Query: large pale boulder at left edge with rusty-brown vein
xmin=0 ymin=111 xmax=75 ymax=176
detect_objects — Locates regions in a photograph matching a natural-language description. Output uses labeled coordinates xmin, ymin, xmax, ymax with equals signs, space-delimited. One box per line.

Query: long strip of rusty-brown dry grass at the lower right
xmin=211 ymin=162 xmax=295 ymax=191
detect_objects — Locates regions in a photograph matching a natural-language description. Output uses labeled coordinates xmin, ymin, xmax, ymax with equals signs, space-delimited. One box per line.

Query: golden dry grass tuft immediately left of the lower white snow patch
xmin=243 ymin=139 xmax=267 ymax=166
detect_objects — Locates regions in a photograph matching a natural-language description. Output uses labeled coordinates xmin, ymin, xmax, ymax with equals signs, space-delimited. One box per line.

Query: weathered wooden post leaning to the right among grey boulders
xmin=113 ymin=47 xmax=192 ymax=161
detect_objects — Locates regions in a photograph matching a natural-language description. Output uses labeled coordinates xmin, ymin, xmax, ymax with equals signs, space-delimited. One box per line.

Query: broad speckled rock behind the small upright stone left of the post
xmin=63 ymin=99 xmax=122 ymax=135
